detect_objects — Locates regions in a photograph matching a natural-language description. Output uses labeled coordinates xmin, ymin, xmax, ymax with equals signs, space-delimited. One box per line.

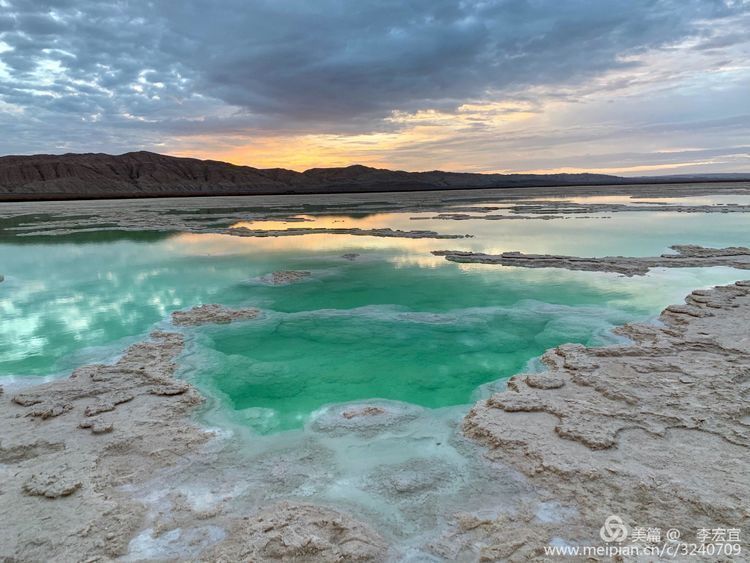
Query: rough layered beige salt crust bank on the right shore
xmin=464 ymin=281 xmax=750 ymax=560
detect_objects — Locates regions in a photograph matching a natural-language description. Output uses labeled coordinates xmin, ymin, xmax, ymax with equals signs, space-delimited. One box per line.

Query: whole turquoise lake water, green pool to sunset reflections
xmin=0 ymin=196 xmax=750 ymax=433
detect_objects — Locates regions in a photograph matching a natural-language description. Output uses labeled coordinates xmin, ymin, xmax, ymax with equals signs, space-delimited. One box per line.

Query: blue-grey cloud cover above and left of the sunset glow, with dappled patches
xmin=0 ymin=0 xmax=750 ymax=165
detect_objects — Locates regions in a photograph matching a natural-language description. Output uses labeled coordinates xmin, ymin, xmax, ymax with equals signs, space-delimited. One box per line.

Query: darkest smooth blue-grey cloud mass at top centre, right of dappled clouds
xmin=151 ymin=0 xmax=742 ymax=121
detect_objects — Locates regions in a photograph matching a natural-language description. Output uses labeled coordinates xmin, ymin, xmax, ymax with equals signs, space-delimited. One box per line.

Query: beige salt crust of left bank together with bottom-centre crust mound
xmin=0 ymin=330 xmax=386 ymax=561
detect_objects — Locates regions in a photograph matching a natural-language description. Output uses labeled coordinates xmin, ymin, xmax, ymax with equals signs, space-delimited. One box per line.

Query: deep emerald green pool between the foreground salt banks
xmin=188 ymin=290 xmax=630 ymax=431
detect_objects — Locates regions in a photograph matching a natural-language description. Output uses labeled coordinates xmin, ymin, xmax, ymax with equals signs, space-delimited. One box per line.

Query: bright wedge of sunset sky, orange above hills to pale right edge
xmin=165 ymin=29 xmax=750 ymax=176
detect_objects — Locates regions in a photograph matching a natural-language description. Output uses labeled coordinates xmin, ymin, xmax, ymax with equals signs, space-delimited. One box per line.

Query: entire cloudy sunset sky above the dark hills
xmin=0 ymin=0 xmax=750 ymax=175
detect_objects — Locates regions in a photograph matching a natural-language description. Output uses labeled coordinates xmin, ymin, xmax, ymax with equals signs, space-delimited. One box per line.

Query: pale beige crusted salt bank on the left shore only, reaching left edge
xmin=0 ymin=332 xmax=207 ymax=561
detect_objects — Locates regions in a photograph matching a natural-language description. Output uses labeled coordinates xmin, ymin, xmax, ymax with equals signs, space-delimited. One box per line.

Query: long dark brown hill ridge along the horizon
xmin=0 ymin=151 xmax=750 ymax=201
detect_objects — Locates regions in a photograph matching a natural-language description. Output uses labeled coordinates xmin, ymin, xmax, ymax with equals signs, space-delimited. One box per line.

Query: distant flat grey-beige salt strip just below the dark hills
xmin=0 ymin=182 xmax=750 ymax=238
